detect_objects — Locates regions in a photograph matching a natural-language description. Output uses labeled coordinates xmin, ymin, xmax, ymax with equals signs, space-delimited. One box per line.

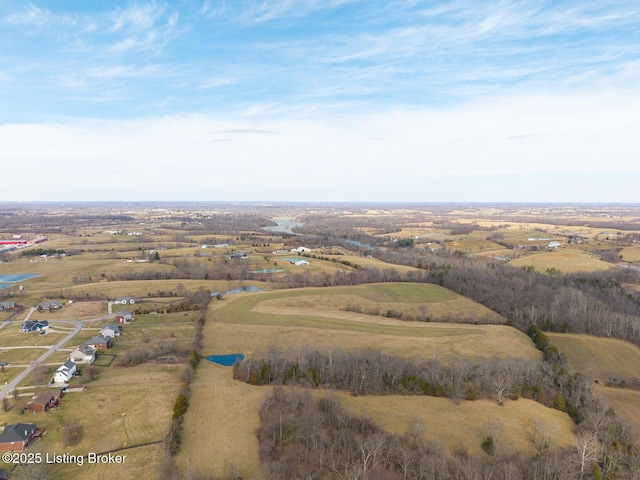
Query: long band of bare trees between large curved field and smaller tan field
xmin=234 ymin=347 xmax=595 ymax=414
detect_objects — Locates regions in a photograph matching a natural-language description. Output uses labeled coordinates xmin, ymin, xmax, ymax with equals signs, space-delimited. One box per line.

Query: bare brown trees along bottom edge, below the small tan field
xmin=257 ymin=387 xmax=640 ymax=480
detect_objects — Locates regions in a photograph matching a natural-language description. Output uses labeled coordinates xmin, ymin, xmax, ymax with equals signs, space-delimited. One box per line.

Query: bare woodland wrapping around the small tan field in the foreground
xmin=234 ymin=344 xmax=640 ymax=479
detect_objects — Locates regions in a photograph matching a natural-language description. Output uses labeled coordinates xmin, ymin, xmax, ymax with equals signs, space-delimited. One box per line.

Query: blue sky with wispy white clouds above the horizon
xmin=0 ymin=0 xmax=640 ymax=203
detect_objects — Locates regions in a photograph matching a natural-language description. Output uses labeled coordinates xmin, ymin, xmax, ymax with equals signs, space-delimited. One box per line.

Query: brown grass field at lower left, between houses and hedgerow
xmin=3 ymin=363 xmax=184 ymax=479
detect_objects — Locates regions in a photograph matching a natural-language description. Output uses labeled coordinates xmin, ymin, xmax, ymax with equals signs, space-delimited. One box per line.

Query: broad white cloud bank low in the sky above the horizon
xmin=0 ymin=89 xmax=640 ymax=201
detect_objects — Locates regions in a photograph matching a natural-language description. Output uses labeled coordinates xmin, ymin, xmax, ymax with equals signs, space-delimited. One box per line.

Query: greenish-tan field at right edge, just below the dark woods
xmin=545 ymin=332 xmax=640 ymax=381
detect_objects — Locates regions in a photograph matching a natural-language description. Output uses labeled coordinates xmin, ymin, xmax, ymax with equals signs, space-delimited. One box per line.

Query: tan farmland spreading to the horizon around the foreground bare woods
xmin=0 ymin=206 xmax=640 ymax=480
